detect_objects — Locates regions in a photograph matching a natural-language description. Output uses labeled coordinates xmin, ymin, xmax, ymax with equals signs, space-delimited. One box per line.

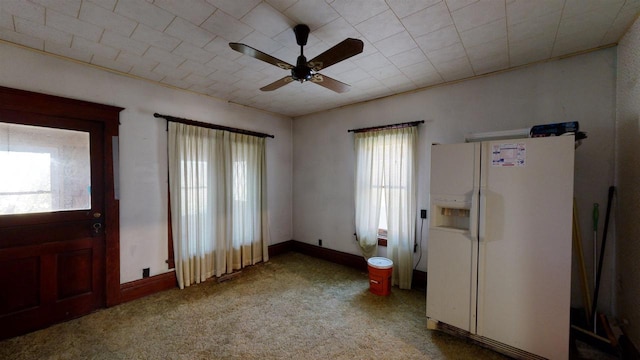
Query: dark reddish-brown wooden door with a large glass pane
xmin=0 ymin=86 xmax=122 ymax=339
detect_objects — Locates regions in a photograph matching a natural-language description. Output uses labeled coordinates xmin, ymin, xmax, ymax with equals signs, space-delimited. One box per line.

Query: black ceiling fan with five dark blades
xmin=229 ymin=24 xmax=364 ymax=93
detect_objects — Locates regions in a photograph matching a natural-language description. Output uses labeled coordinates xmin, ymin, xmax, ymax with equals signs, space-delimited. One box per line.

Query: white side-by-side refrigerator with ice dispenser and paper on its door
xmin=427 ymin=136 xmax=574 ymax=359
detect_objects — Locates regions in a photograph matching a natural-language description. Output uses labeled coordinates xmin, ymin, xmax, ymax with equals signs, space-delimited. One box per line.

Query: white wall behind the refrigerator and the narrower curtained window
xmin=293 ymin=49 xmax=615 ymax=313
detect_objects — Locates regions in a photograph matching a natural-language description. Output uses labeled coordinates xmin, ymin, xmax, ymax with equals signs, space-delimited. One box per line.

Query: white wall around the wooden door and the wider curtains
xmin=0 ymin=43 xmax=292 ymax=283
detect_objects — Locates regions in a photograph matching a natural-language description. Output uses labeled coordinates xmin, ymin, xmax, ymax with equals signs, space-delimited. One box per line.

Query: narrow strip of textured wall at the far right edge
xmin=614 ymin=16 xmax=640 ymax=346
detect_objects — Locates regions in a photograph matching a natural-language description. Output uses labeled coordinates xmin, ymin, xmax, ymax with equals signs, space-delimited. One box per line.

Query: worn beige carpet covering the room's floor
xmin=0 ymin=253 xmax=504 ymax=359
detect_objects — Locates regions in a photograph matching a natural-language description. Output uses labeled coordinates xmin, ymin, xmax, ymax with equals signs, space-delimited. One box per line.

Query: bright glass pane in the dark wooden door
xmin=0 ymin=123 xmax=91 ymax=215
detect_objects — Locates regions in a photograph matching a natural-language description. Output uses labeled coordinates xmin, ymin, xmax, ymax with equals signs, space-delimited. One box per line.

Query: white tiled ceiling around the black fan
xmin=0 ymin=0 xmax=640 ymax=116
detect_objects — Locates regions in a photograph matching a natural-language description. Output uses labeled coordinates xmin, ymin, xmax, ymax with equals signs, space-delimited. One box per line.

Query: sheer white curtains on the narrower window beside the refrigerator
xmin=355 ymin=126 xmax=417 ymax=289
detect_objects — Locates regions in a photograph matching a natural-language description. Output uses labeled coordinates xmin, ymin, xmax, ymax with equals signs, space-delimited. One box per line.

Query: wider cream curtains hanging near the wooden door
xmin=168 ymin=122 xmax=269 ymax=288
